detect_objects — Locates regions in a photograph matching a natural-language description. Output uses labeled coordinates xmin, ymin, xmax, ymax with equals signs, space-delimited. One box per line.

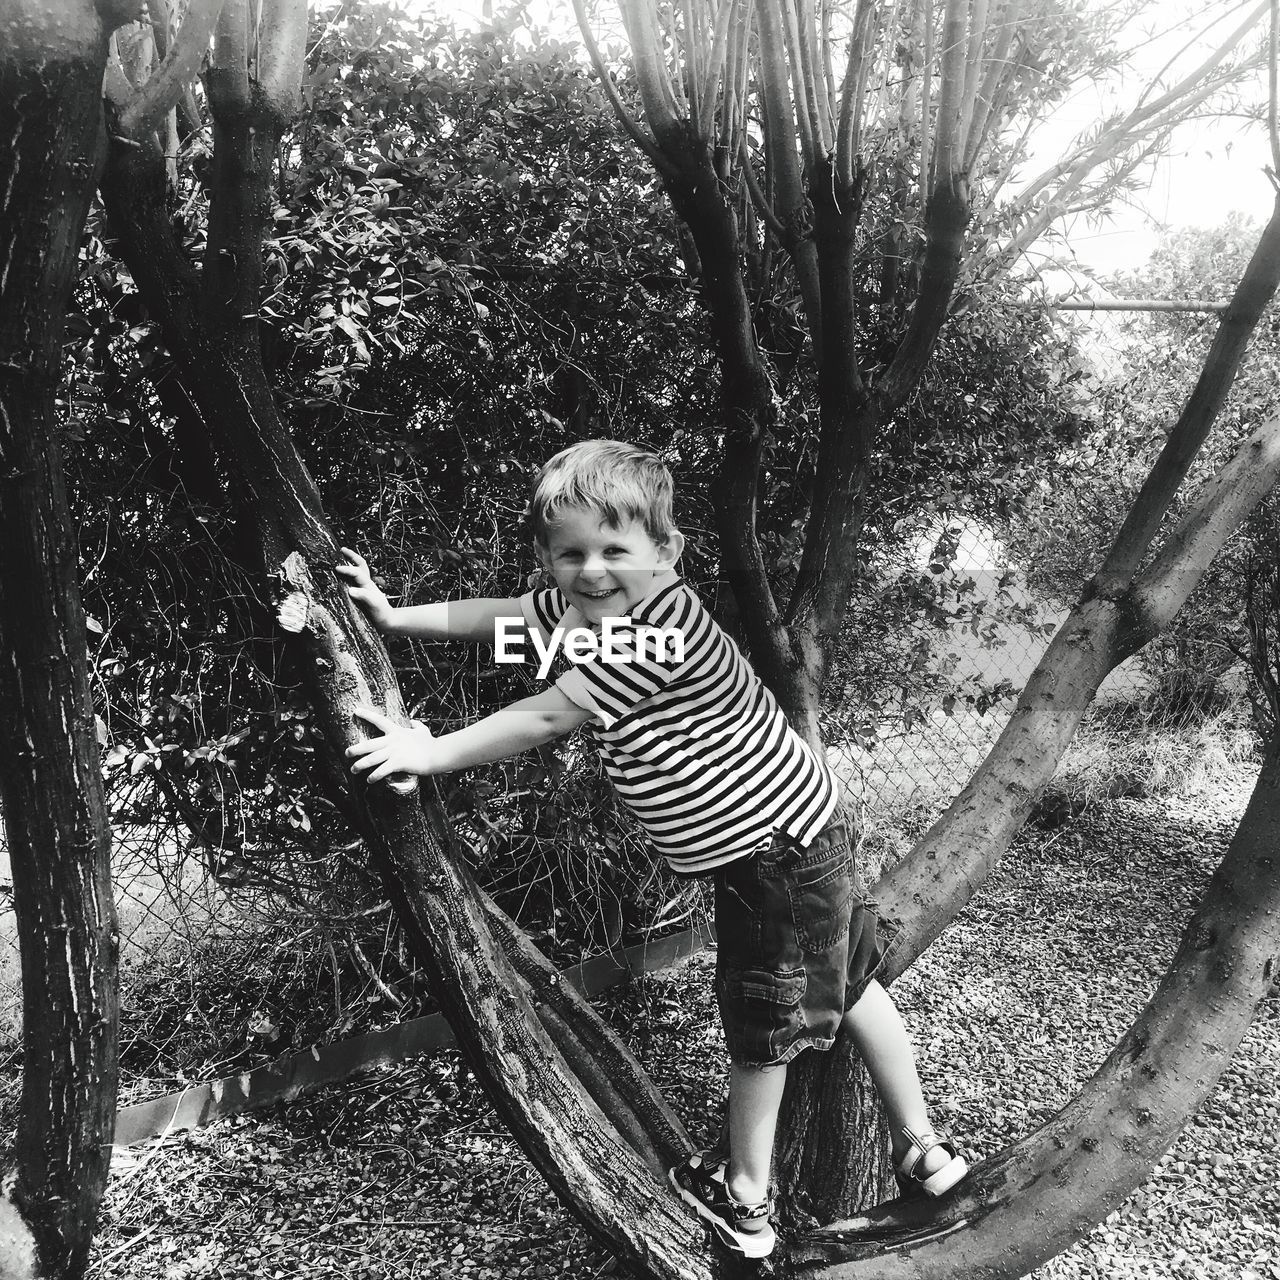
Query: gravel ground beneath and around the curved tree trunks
xmin=90 ymin=786 xmax=1280 ymax=1280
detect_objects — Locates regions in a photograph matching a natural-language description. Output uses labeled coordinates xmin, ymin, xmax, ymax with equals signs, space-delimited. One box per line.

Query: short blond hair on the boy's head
xmin=527 ymin=440 xmax=675 ymax=547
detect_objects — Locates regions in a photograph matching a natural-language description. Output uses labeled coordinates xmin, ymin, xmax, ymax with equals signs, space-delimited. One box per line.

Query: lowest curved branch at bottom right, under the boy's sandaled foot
xmin=788 ymin=754 xmax=1280 ymax=1280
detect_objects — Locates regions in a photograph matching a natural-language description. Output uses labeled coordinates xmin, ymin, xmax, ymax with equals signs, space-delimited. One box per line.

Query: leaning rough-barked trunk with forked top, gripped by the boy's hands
xmin=101 ymin=0 xmax=704 ymax=1276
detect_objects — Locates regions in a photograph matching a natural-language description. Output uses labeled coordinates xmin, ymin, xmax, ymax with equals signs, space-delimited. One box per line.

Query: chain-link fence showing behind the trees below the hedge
xmin=0 ymin=568 xmax=1239 ymax=1076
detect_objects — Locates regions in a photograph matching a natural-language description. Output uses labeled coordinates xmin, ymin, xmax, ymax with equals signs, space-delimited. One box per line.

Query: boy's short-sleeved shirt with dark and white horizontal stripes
xmin=520 ymin=573 xmax=837 ymax=873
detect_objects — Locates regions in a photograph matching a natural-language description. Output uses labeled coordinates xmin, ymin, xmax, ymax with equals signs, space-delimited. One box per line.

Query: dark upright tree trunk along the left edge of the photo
xmin=0 ymin=0 xmax=128 ymax=1277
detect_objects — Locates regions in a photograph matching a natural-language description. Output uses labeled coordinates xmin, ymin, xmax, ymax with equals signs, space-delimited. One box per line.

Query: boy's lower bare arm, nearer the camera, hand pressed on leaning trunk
xmin=347 ymin=689 xmax=591 ymax=782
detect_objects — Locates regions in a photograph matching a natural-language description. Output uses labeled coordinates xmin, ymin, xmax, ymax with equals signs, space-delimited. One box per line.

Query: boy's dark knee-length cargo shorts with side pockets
xmin=713 ymin=814 xmax=893 ymax=1066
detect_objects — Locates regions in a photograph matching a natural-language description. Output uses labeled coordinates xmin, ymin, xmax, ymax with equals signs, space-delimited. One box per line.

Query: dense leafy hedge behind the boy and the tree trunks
xmin=64 ymin=6 xmax=1074 ymax=998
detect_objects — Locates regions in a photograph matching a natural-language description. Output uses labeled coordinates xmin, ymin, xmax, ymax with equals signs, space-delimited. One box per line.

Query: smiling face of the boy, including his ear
xmin=535 ymin=507 xmax=685 ymax=625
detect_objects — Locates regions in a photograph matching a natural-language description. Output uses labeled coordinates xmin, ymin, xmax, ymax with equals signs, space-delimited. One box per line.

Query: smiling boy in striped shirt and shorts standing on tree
xmin=338 ymin=440 xmax=966 ymax=1258
